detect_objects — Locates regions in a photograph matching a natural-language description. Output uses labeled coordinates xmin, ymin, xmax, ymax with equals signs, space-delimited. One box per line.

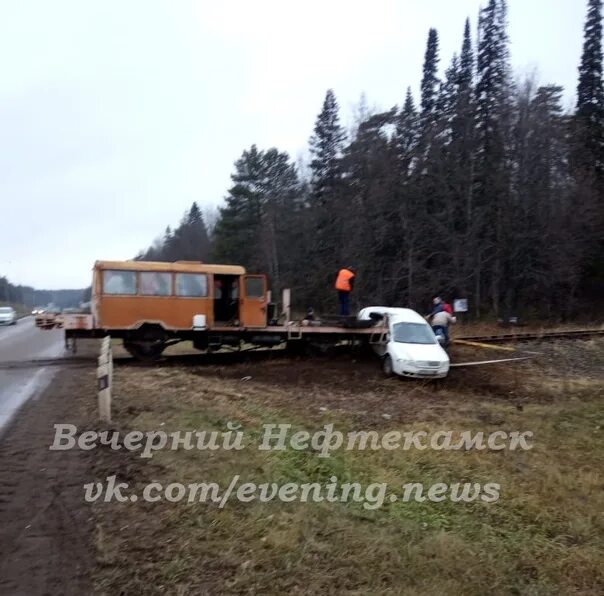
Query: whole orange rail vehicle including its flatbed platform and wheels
xmin=36 ymin=261 xmax=385 ymax=359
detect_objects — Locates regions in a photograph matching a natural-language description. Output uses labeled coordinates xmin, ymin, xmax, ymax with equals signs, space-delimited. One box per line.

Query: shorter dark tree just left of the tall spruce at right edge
xmin=507 ymin=81 xmax=584 ymax=314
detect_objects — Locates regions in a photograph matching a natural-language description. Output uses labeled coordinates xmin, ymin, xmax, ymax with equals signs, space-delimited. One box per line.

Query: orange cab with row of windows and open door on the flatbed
xmin=92 ymin=261 xmax=267 ymax=330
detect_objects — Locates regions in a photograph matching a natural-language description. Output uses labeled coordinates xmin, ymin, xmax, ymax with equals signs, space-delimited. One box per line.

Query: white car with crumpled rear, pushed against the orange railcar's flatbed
xmin=358 ymin=306 xmax=450 ymax=379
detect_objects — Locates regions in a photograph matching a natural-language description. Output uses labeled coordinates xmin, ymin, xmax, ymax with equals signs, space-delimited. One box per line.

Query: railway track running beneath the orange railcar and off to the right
xmin=0 ymin=329 xmax=604 ymax=370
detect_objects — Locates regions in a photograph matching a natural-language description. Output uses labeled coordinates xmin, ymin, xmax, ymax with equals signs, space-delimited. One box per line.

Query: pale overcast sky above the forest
xmin=0 ymin=0 xmax=586 ymax=289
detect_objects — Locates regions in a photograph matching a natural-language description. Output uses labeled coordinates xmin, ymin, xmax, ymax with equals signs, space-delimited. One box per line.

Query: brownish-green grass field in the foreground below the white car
xmin=95 ymin=340 xmax=604 ymax=595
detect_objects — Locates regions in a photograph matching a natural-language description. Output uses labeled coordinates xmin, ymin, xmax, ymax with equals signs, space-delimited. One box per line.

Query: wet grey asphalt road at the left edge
xmin=0 ymin=317 xmax=64 ymax=432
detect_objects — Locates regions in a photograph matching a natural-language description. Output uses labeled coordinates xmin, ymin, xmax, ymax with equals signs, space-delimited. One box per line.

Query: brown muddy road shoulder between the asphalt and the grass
xmin=0 ymin=368 xmax=95 ymax=596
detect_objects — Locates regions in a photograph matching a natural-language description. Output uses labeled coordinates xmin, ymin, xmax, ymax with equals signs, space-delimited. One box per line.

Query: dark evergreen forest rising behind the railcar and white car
xmin=137 ymin=0 xmax=604 ymax=318
